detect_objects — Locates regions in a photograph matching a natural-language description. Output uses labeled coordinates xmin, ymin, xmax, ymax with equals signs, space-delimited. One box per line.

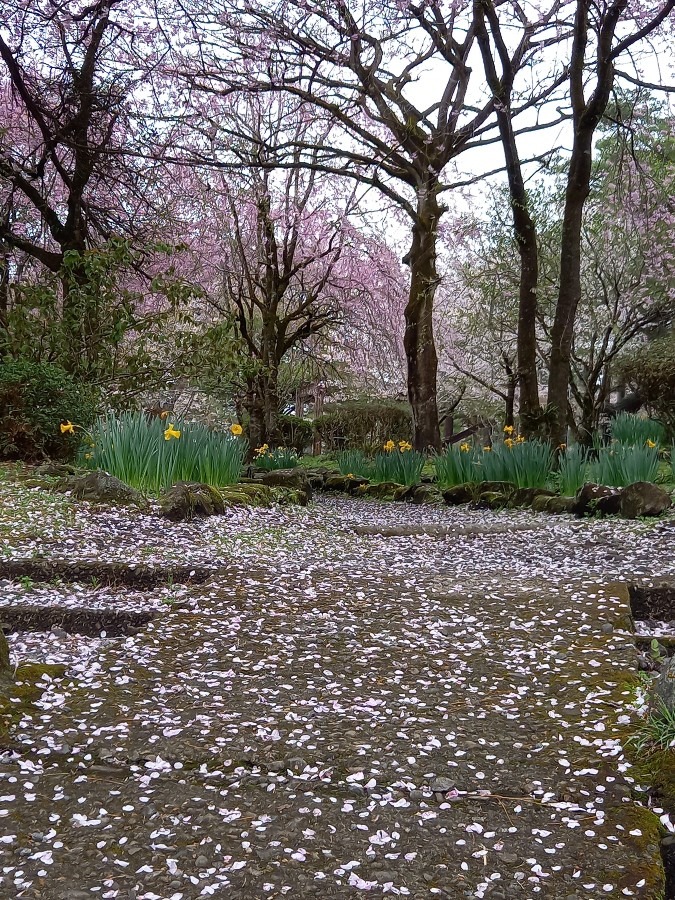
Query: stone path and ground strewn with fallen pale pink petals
xmin=0 ymin=474 xmax=675 ymax=900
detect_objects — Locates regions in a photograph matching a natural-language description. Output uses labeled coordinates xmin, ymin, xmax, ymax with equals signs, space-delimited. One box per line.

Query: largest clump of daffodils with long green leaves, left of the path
xmin=81 ymin=412 xmax=248 ymax=494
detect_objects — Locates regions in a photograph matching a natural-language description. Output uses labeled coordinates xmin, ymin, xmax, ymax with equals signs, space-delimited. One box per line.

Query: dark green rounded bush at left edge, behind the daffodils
xmin=0 ymin=360 xmax=97 ymax=461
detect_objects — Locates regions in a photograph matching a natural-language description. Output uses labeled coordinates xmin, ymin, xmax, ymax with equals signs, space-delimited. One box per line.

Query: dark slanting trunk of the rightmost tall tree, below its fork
xmin=548 ymin=134 xmax=595 ymax=445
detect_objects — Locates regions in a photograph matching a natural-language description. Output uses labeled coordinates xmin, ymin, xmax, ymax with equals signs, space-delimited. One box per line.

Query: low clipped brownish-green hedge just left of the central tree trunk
xmin=314 ymin=400 xmax=412 ymax=453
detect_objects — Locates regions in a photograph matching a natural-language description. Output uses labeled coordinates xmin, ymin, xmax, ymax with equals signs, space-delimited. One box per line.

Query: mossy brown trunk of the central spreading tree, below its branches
xmin=403 ymin=182 xmax=443 ymax=451
